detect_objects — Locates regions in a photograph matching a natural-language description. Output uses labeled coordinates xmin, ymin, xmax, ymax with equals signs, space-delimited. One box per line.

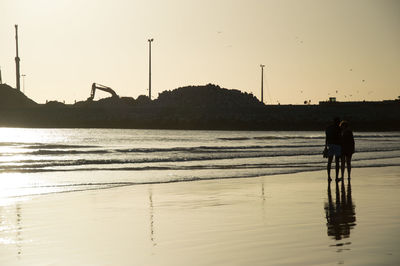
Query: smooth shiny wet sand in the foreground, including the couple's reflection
xmin=0 ymin=167 xmax=400 ymax=266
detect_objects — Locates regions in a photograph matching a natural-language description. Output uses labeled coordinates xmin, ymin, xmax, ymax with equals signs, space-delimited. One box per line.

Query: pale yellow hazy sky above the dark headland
xmin=0 ymin=0 xmax=400 ymax=104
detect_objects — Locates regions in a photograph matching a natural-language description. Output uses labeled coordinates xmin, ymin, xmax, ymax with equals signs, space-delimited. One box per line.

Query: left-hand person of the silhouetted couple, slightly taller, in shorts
xmin=325 ymin=117 xmax=342 ymax=181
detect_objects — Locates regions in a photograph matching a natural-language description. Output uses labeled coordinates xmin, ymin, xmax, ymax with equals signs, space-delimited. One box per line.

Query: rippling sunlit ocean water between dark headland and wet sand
xmin=0 ymin=128 xmax=400 ymax=200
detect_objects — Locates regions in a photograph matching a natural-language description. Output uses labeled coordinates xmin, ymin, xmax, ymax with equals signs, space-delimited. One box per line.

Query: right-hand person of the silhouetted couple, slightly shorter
xmin=340 ymin=121 xmax=355 ymax=179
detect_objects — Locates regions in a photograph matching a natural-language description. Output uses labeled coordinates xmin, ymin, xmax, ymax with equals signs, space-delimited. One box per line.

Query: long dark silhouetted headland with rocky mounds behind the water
xmin=0 ymin=84 xmax=400 ymax=131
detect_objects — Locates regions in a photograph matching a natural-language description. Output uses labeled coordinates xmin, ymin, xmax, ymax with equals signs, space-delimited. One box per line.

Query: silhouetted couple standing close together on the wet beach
xmin=324 ymin=117 xmax=354 ymax=181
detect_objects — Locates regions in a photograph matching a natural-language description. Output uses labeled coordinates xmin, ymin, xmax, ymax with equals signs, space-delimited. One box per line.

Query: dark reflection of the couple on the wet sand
xmin=324 ymin=180 xmax=356 ymax=252
